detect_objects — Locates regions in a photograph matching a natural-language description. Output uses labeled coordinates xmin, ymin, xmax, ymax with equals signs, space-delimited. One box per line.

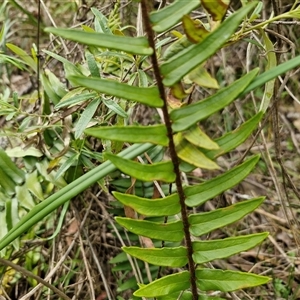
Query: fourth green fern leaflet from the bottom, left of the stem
xmin=113 ymin=192 xmax=180 ymax=216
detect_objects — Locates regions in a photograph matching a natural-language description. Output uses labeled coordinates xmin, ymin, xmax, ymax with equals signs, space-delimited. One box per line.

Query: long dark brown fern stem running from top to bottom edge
xmin=141 ymin=0 xmax=198 ymax=300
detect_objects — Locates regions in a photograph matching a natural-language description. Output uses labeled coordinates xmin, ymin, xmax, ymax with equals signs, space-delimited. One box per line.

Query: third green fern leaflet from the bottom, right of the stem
xmin=189 ymin=197 xmax=265 ymax=236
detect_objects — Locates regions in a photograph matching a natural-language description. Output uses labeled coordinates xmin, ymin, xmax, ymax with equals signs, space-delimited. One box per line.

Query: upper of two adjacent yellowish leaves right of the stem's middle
xmin=183 ymin=126 xmax=219 ymax=150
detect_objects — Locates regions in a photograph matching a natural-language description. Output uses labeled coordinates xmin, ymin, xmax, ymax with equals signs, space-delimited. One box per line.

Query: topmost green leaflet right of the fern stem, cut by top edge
xmin=150 ymin=0 xmax=200 ymax=32
